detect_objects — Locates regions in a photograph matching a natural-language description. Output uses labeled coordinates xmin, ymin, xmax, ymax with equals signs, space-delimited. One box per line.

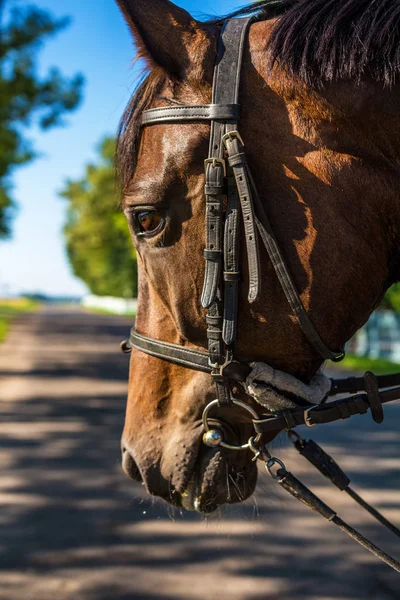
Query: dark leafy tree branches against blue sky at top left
xmin=0 ymin=0 xmax=83 ymax=239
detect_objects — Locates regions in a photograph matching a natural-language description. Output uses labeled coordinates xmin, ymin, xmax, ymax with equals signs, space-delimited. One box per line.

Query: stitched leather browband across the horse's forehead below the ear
xmin=141 ymin=103 xmax=240 ymax=125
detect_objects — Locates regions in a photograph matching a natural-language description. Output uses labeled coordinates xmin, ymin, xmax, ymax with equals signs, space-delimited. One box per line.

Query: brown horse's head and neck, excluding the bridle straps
xmin=118 ymin=0 xmax=400 ymax=512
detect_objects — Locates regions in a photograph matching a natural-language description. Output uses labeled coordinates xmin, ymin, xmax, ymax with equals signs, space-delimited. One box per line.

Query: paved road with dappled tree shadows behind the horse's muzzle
xmin=0 ymin=308 xmax=400 ymax=600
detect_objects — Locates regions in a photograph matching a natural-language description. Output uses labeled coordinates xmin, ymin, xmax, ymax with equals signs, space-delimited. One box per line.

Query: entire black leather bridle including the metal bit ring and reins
xmin=121 ymin=18 xmax=400 ymax=572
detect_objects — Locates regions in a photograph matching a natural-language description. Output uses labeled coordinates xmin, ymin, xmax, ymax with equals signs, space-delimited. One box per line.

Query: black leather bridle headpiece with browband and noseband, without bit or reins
xmin=121 ymin=19 xmax=344 ymax=404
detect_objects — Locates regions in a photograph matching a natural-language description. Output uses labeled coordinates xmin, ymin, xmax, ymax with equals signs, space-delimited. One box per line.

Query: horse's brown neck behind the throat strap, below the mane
xmin=241 ymin=30 xmax=400 ymax=364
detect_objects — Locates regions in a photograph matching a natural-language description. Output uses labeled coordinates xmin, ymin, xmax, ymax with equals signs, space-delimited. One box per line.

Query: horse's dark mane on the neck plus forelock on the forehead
xmin=116 ymin=0 xmax=400 ymax=187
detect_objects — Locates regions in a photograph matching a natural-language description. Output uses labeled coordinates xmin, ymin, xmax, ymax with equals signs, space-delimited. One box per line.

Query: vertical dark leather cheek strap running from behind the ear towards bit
xmin=202 ymin=19 xmax=251 ymax=405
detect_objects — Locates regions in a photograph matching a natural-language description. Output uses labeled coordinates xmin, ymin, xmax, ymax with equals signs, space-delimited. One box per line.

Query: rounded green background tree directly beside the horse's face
xmin=61 ymin=138 xmax=137 ymax=297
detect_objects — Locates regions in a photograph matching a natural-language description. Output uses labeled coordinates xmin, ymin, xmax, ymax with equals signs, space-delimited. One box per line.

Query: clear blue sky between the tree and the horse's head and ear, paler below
xmin=0 ymin=0 xmax=246 ymax=296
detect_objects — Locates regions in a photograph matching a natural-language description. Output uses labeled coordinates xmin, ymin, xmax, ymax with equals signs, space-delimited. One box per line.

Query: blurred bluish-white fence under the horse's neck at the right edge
xmin=348 ymin=310 xmax=400 ymax=363
